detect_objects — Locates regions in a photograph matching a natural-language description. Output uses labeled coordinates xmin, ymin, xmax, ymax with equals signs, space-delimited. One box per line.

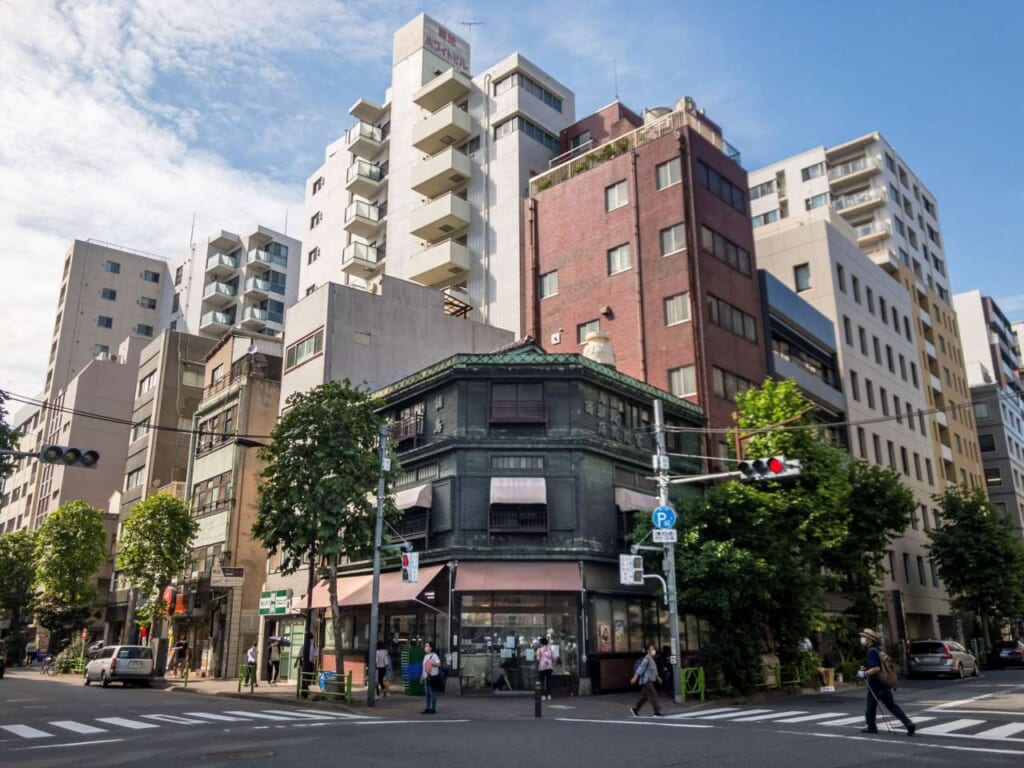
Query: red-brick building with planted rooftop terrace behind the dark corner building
xmin=523 ymin=98 xmax=767 ymax=456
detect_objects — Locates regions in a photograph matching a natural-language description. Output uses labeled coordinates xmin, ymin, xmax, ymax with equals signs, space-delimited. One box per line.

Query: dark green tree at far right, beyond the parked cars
xmin=929 ymin=485 xmax=1024 ymax=646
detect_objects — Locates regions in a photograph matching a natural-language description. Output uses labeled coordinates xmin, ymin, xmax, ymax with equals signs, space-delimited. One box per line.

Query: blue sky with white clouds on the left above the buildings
xmin=0 ymin=0 xmax=1024 ymax=396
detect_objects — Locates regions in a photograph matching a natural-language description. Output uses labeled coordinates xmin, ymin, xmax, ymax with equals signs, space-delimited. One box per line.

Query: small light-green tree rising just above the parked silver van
xmin=118 ymin=494 xmax=199 ymax=625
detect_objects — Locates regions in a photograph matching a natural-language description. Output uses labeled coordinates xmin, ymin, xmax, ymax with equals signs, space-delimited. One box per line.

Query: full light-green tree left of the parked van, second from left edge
xmin=35 ymin=500 xmax=109 ymax=647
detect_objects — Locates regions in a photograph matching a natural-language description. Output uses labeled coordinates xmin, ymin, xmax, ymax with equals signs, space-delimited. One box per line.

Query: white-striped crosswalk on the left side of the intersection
xmin=0 ymin=709 xmax=375 ymax=740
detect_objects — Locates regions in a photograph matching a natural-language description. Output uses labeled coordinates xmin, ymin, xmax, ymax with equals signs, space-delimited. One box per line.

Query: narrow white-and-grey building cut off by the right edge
xmin=953 ymin=291 xmax=1024 ymax=536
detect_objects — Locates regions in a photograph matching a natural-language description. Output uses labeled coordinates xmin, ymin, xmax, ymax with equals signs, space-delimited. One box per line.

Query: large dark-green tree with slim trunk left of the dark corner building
xmin=253 ymin=379 xmax=397 ymax=677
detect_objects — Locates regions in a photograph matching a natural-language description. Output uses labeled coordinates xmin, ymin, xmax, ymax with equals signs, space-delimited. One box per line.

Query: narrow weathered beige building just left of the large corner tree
xmin=172 ymin=331 xmax=282 ymax=677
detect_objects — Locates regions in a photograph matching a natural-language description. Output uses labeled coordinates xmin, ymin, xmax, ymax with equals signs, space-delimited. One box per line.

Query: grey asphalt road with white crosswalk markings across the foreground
xmin=0 ymin=670 xmax=1024 ymax=768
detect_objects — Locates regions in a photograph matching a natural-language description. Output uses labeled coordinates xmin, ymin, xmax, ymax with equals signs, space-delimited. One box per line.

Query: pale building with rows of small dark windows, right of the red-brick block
xmin=757 ymin=206 xmax=956 ymax=639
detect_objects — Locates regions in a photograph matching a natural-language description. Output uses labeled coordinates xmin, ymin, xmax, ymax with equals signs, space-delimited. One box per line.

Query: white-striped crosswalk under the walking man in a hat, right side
xmin=652 ymin=707 xmax=1024 ymax=743
